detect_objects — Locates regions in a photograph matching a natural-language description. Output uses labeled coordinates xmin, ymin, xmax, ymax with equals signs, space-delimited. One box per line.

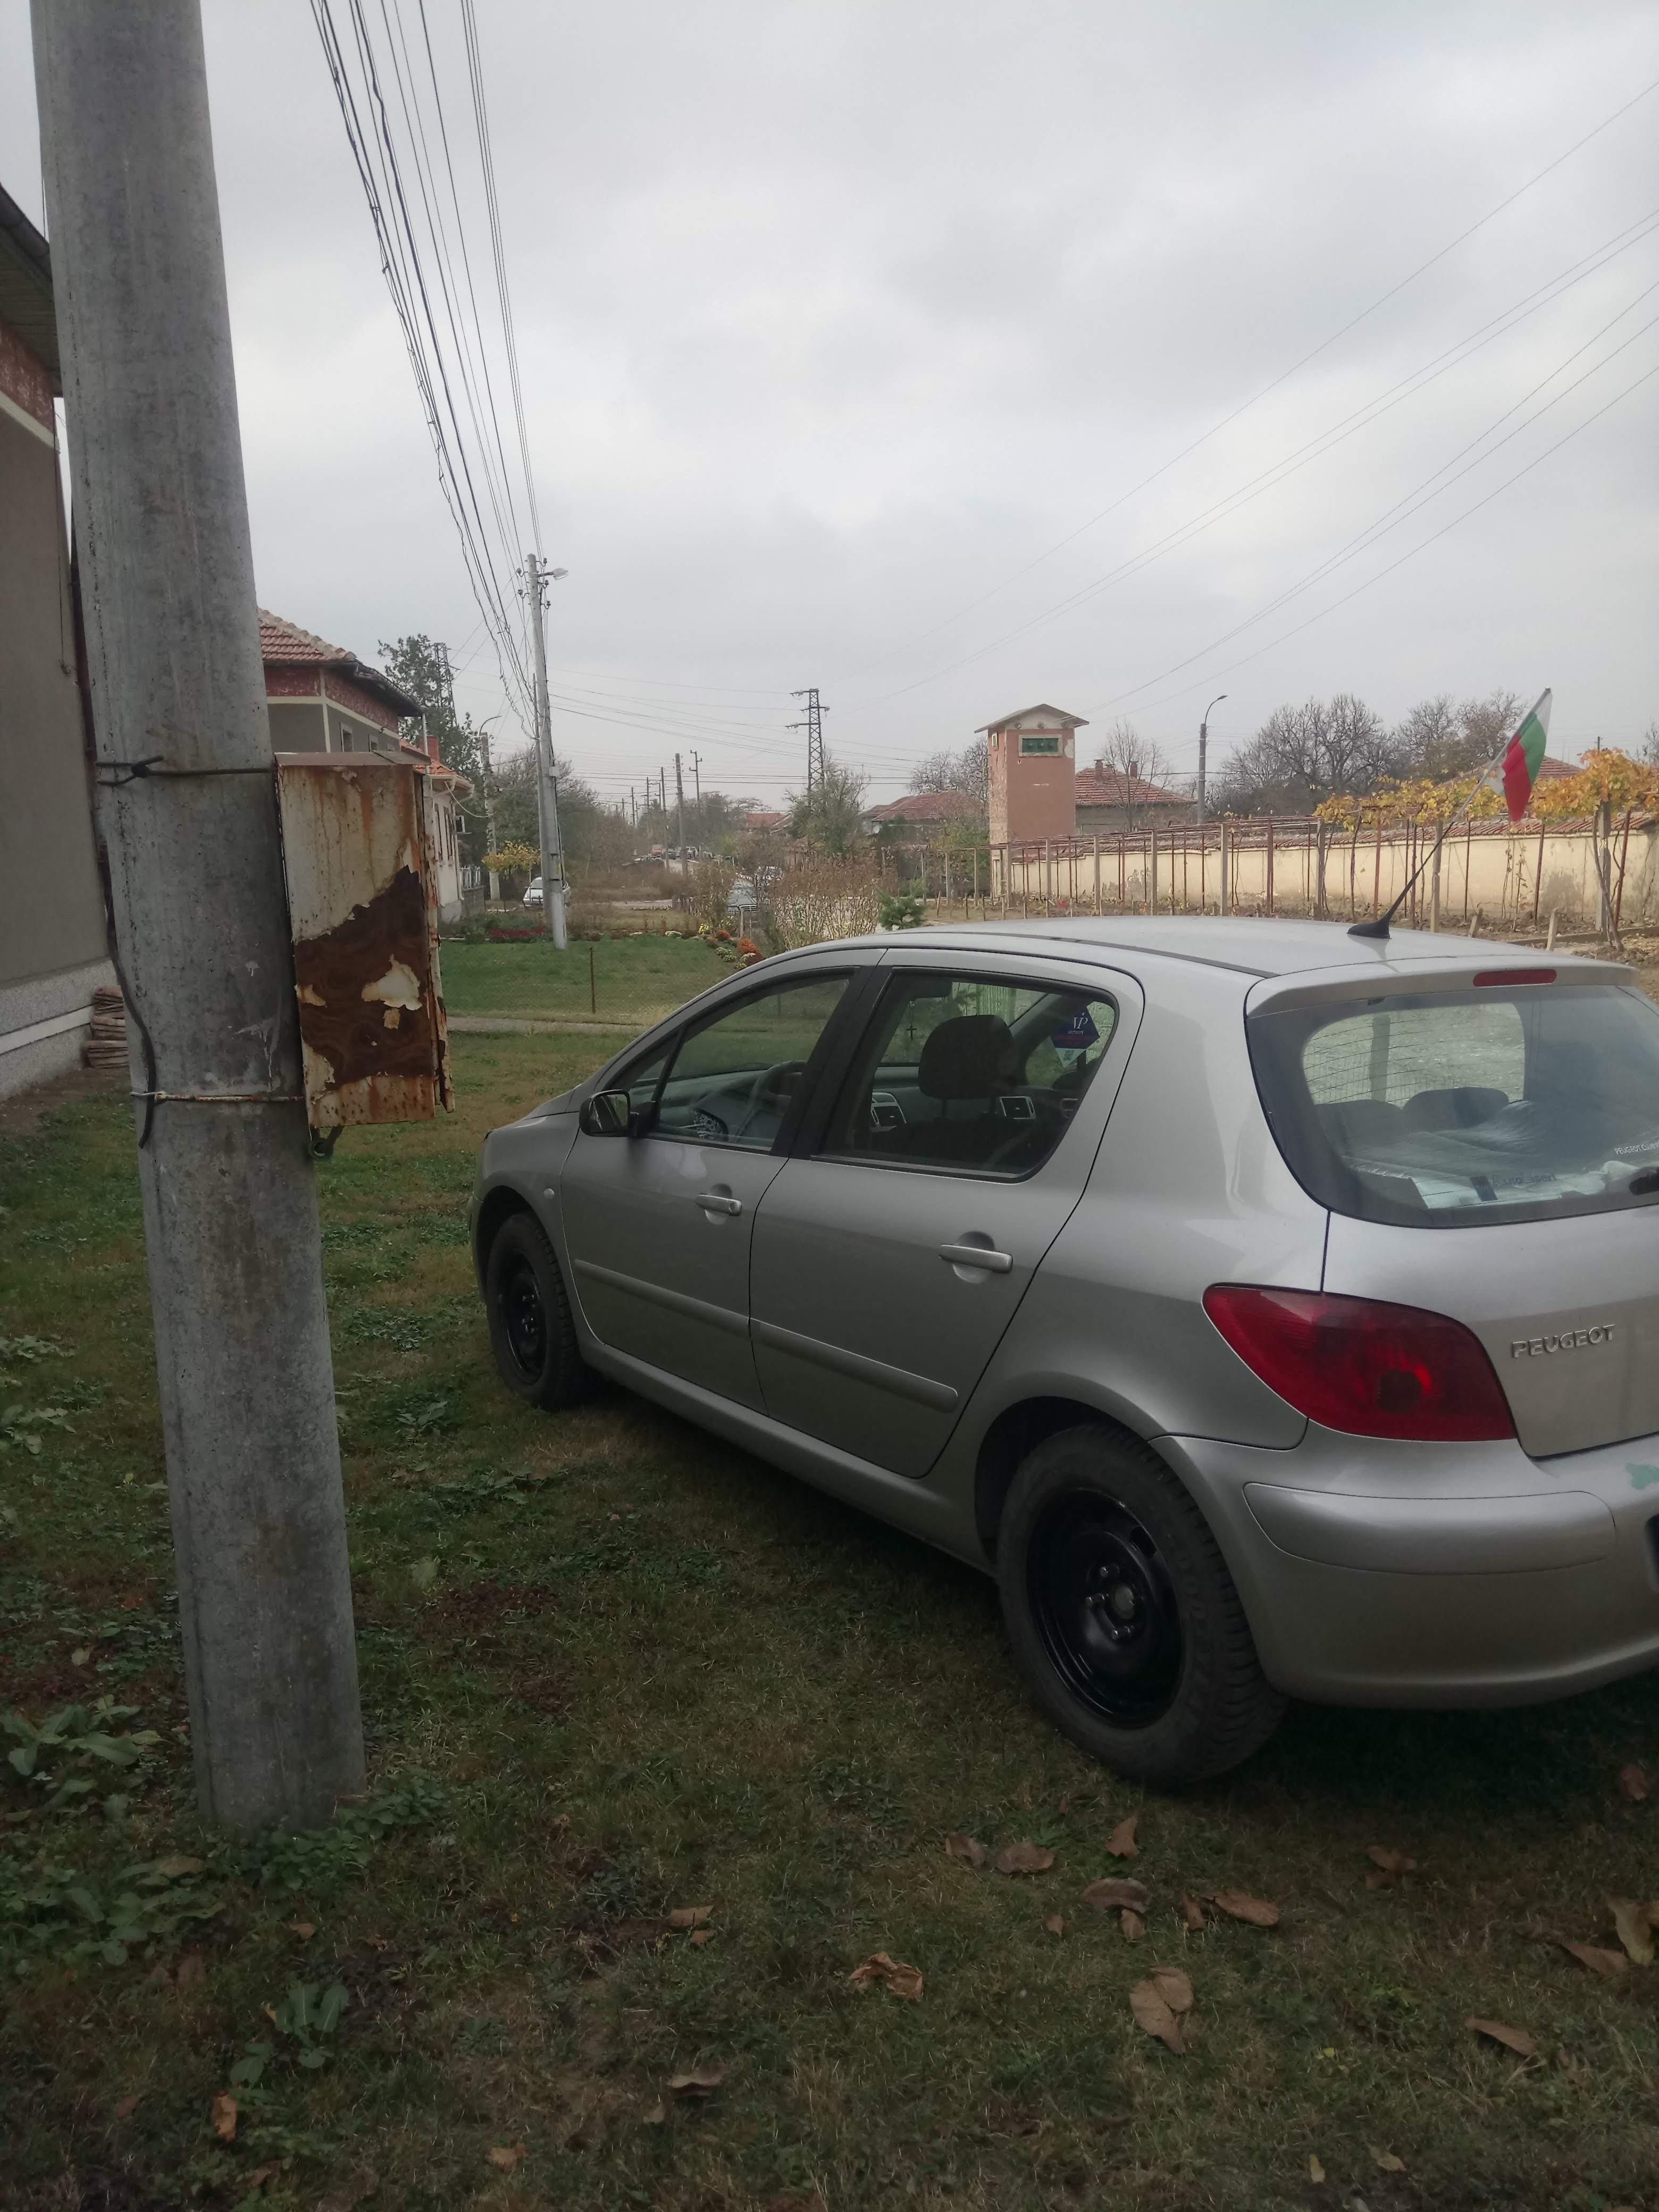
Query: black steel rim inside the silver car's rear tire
xmin=1026 ymin=1491 xmax=1181 ymax=1728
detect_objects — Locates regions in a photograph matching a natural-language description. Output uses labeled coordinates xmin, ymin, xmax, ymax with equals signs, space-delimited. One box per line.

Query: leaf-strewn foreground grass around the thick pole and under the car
xmin=0 ymin=1040 xmax=1659 ymax=2212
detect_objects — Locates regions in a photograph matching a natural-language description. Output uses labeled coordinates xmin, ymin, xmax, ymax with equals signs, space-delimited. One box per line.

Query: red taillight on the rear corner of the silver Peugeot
xmin=1203 ymin=1283 xmax=1515 ymax=1444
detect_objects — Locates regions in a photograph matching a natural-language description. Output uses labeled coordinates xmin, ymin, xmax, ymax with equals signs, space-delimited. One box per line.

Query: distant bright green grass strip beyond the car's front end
xmin=442 ymin=936 xmax=730 ymax=1028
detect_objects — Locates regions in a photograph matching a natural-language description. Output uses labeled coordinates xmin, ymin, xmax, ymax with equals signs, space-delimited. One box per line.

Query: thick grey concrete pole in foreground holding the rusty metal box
xmin=33 ymin=0 xmax=363 ymax=1829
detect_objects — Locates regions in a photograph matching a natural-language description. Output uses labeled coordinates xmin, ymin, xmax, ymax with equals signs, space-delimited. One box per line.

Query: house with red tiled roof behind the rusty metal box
xmin=259 ymin=606 xmax=471 ymax=920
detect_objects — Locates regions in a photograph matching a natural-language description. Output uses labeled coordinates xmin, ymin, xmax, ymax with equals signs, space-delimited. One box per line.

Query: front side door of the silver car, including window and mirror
xmin=557 ymin=967 xmax=856 ymax=1407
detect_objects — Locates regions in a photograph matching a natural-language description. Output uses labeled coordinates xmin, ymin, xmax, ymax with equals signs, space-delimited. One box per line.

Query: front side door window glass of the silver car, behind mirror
xmin=646 ymin=976 xmax=849 ymax=1152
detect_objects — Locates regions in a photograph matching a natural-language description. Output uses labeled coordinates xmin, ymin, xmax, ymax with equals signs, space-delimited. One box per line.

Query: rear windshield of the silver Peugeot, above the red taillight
xmin=1247 ymin=984 xmax=1659 ymax=1230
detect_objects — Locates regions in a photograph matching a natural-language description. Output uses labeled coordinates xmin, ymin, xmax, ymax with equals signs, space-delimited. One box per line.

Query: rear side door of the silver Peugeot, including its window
xmin=750 ymin=953 xmax=1139 ymax=1476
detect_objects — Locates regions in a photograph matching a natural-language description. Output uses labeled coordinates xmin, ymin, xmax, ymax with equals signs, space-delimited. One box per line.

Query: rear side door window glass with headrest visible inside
xmin=823 ymin=973 xmax=1117 ymax=1177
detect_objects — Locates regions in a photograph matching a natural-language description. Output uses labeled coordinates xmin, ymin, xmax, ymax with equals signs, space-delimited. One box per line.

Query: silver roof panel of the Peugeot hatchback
xmin=814 ymin=914 xmax=1608 ymax=982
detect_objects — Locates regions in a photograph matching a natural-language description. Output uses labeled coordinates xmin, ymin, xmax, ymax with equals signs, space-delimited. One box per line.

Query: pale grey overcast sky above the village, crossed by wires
xmin=0 ymin=0 xmax=1659 ymax=801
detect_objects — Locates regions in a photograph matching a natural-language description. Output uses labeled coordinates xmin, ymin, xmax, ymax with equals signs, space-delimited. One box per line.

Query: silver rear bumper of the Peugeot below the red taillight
xmin=1159 ymin=1431 xmax=1659 ymax=1705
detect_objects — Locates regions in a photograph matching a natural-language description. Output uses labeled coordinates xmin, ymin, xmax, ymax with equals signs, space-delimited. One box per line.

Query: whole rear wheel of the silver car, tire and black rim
xmin=998 ymin=1425 xmax=1285 ymax=1787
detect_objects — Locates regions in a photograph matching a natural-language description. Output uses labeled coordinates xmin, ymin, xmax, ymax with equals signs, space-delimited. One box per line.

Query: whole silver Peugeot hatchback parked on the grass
xmin=473 ymin=918 xmax=1659 ymax=1783
